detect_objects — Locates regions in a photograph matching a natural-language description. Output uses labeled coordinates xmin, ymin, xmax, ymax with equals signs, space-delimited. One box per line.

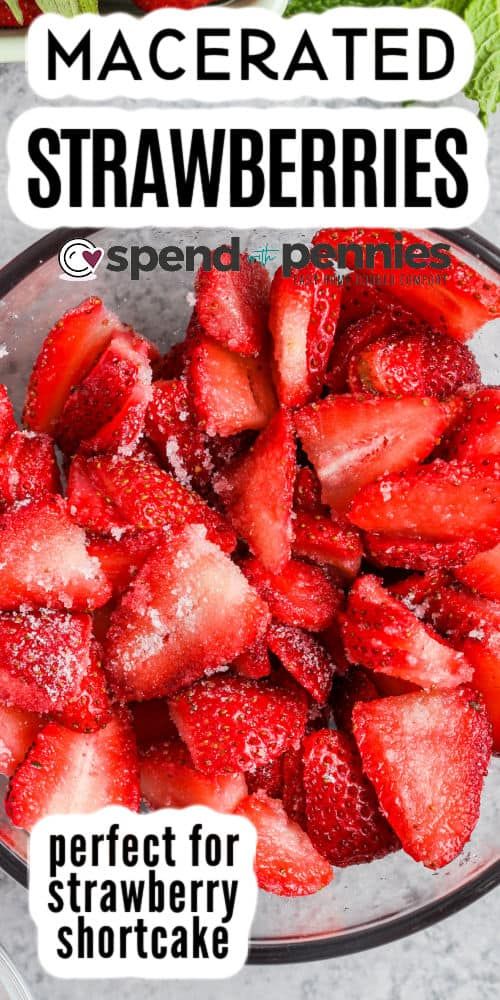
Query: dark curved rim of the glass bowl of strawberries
xmin=0 ymin=227 xmax=500 ymax=965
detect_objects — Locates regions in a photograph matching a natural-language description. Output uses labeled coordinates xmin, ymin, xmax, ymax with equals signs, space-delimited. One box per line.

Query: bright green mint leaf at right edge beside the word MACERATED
xmin=464 ymin=0 xmax=500 ymax=125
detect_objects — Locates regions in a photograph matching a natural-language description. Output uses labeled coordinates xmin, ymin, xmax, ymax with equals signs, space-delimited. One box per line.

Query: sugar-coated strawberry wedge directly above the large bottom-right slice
xmin=343 ymin=576 xmax=472 ymax=688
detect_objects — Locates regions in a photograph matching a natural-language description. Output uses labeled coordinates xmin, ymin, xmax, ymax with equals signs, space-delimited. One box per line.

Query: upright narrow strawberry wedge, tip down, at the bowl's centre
xmin=214 ymin=410 xmax=296 ymax=573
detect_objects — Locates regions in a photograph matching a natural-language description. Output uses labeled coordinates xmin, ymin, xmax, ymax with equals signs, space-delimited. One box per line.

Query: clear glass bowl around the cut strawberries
xmin=0 ymin=229 xmax=500 ymax=963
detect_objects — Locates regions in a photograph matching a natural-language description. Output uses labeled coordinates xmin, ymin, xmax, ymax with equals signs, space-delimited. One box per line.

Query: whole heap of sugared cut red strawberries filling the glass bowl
xmin=0 ymin=230 xmax=500 ymax=896
